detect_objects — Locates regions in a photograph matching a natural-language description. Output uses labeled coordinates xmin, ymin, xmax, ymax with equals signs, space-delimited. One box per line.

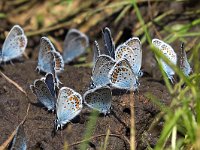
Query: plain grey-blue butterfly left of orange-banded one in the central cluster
xmin=91 ymin=55 xmax=115 ymax=88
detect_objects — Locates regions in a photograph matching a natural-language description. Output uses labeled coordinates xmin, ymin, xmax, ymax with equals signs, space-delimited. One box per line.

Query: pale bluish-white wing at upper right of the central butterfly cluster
xmin=125 ymin=37 xmax=142 ymax=75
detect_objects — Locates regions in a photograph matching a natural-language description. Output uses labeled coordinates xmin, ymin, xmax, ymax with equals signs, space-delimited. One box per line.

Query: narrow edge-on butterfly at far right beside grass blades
xmin=180 ymin=43 xmax=192 ymax=76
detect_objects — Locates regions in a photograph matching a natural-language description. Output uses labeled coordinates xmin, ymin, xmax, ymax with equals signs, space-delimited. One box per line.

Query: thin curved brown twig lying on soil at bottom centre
xmin=68 ymin=134 xmax=130 ymax=147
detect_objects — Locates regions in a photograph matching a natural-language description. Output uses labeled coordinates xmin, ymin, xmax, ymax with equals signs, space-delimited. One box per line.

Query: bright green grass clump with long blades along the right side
xmin=132 ymin=0 xmax=200 ymax=150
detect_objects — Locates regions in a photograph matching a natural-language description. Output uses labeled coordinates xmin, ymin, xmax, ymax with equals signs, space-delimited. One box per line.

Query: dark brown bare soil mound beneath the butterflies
xmin=0 ymin=61 xmax=170 ymax=150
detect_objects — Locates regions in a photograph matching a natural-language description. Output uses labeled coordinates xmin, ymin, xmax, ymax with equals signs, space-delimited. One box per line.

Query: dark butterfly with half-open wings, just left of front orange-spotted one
xmin=30 ymin=73 xmax=56 ymax=111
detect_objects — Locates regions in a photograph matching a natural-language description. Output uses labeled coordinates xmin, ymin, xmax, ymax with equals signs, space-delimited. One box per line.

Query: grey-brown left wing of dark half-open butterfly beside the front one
xmin=30 ymin=80 xmax=56 ymax=111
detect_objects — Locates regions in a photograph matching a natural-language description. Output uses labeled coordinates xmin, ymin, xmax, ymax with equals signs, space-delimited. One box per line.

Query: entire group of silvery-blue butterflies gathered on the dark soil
xmin=0 ymin=25 xmax=192 ymax=149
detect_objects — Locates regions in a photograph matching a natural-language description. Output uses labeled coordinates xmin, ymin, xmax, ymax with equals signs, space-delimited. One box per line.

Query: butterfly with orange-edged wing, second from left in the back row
xmin=36 ymin=37 xmax=64 ymax=73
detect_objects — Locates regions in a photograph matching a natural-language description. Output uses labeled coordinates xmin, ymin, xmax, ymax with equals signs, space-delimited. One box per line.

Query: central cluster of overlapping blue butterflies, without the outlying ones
xmin=31 ymin=28 xmax=145 ymax=130
